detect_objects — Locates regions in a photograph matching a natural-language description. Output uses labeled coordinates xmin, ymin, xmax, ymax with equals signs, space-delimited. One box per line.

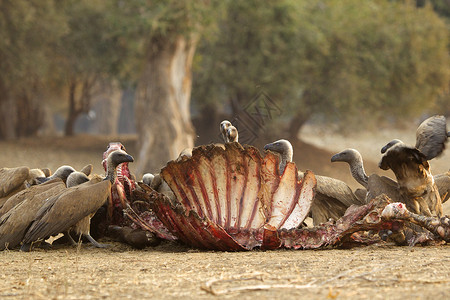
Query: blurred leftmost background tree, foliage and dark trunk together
xmin=0 ymin=0 xmax=66 ymax=139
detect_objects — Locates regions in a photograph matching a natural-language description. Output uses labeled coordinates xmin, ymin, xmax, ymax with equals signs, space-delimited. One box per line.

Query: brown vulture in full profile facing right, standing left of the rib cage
xmin=21 ymin=150 xmax=133 ymax=251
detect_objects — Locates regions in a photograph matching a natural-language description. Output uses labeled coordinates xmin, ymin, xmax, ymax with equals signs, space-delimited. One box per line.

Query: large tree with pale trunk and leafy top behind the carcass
xmin=107 ymin=0 xmax=220 ymax=174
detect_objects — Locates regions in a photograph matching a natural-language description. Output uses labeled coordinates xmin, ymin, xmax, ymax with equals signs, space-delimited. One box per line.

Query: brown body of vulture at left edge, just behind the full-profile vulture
xmin=0 ymin=178 xmax=67 ymax=250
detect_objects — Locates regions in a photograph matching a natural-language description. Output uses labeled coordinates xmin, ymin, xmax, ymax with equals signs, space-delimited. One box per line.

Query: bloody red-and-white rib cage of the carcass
xmin=149 ymin=143 xmax=316 ymax=250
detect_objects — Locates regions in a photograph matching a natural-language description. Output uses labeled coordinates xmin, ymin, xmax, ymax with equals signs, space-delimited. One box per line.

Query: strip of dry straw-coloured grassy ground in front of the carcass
xmin=0 ymin=243 xmax=450 ymax=299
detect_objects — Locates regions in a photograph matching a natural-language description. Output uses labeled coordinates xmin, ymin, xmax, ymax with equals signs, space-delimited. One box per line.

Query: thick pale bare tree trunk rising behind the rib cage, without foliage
xmin=135 ymin=36 xmax=197 ymax=176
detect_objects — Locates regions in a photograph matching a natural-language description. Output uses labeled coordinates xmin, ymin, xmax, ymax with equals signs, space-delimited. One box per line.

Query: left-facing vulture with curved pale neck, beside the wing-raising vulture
xmin=331 ymin=148 xmax=401 ymax=202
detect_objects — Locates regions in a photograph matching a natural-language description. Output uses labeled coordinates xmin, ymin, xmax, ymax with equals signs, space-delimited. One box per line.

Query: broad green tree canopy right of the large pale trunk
xmin=193 ymin=0 xmax=450 ymax=131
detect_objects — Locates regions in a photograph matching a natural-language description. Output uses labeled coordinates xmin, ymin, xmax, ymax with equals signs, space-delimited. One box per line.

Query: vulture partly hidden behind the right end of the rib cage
xmin=264 ymin=140 xmax=364 ymax=225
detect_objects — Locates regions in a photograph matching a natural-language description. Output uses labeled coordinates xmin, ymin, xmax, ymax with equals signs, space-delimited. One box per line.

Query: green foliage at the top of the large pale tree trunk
xmin=100 ymin=0 xmax=225 ymax=82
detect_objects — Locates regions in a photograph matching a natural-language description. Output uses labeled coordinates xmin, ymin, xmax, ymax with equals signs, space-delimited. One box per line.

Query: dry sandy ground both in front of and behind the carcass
xmin=0 ymin=129 xmax=450 ymax=299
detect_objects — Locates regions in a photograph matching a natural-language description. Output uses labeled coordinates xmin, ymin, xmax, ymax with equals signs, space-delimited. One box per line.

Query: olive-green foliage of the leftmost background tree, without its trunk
xmin=0 ymin=0 xmax=66 ymax=91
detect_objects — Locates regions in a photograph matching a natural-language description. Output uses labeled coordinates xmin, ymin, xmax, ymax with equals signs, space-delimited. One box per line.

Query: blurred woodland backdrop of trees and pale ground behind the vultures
xmin=0 ymin=0 xmax=450 ymax=186
